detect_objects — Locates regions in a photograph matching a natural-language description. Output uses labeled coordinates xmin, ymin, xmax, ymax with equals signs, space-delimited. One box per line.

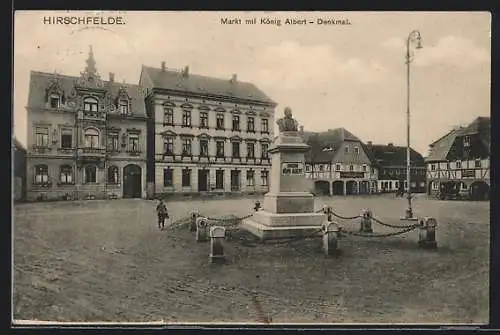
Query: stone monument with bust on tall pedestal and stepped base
xmin=242 ymin=107 xmax=326 ymax=240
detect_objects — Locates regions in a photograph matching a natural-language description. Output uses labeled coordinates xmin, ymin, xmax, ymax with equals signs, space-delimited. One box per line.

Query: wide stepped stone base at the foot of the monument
xmin=241 ymin=211 xmax=326 ymax=240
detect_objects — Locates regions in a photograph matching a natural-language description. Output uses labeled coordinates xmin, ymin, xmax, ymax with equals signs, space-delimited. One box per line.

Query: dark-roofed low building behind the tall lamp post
xmin=366 ymin=141 xmax=426 ymax=193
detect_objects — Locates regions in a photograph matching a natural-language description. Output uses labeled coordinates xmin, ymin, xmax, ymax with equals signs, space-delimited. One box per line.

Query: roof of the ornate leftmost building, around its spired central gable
xmin=28 ymin=71 xmax=146 ymax=116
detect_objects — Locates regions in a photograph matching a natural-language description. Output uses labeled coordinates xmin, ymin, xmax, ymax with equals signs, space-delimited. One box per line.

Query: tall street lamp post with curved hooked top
xmin=405 ymin=30 xmax=422 ymax=219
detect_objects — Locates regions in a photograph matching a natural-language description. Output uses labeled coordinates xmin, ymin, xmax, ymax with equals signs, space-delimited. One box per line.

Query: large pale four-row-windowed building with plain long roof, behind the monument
xmin=140 ymin=62 xmax=276 ymax=197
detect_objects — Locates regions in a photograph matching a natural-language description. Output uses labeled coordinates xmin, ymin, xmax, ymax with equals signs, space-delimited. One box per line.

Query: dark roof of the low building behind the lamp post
xmin=366 ymin=144 xmax=425 ymax=166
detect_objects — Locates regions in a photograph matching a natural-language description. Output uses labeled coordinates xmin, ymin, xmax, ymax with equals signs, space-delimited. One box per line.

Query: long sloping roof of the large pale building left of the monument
xmin=141 ymin=65 xmax=276 ymax=106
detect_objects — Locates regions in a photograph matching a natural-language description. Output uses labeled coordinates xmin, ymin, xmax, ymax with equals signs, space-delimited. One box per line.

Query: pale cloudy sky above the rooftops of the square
xmin=14 ymin=11 xmax=490 ymax=155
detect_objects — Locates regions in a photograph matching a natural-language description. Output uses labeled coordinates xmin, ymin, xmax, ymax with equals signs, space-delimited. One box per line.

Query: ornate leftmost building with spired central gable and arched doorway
xmin=27 ymin=48 xmax=147 ymax=200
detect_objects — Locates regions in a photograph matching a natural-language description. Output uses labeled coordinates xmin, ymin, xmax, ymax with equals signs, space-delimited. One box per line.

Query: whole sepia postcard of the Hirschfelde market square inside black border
xmin=11 ymin=11 xmax=491 ymax=327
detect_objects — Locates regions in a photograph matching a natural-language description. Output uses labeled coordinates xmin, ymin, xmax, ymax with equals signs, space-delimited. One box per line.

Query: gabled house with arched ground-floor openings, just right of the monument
xmin=301 ymin=128 xmax=377 ymax=195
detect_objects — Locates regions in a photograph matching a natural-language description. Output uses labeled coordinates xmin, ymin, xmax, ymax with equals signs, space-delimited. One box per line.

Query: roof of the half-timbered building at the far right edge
xmin=425 ymin=116 xmax=491 ymax=162
